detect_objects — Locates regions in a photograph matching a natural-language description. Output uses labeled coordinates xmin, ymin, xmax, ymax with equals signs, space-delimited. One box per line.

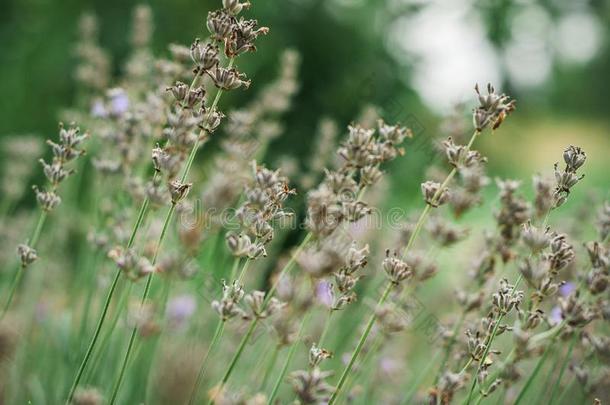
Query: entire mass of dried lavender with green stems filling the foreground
xmin=0 ymin=0 xmax=610 ymax=405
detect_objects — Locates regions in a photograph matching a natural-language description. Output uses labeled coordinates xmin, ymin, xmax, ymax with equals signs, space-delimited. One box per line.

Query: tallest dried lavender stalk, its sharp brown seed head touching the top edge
xmin=110 ymin=0 xmax=268 ymax=404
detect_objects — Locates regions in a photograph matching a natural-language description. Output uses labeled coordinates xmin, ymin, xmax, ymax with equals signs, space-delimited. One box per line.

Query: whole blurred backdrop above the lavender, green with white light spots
xmin=0 ymin=0 xmax=610 ymax=198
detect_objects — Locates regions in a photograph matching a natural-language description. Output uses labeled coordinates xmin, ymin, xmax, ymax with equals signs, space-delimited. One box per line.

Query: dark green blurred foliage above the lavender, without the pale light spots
xmin=0 ymin=0 xmax=610 ymax=200
